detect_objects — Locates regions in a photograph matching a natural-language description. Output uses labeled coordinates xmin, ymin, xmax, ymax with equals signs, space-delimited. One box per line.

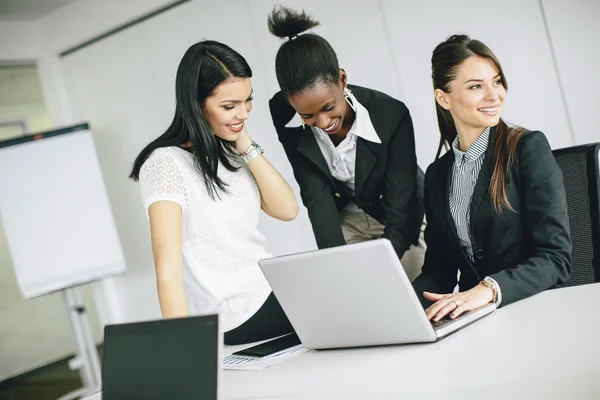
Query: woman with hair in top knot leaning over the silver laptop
xmin=268 ymin=7 xmax=424 ymax=280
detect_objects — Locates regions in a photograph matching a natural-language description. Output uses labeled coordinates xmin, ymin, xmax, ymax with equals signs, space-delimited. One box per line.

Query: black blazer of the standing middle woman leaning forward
xmin=269 ymin=86 xmax=424 ymax=257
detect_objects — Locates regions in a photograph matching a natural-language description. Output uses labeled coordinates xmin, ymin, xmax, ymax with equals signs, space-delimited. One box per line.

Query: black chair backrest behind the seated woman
xmin=553 ymin=143 xmax=600 ymax=286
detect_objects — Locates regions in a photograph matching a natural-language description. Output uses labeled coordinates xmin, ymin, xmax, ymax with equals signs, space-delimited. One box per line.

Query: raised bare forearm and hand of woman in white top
xmin=236 ymin=128 xmax=298 ymax=221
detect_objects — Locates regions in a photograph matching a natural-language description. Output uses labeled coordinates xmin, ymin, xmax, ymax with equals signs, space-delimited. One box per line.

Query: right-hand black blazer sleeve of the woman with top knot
xmin=382 ymin=106 xmax=423 ymax=258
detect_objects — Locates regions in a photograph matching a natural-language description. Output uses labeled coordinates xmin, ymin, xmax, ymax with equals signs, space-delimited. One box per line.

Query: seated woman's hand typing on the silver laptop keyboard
xmin=423 ymin=284 xmax=494 ymax=321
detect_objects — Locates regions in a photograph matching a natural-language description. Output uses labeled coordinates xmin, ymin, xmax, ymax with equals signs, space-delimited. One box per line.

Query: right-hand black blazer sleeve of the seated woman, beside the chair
xmin=490 ymin=132 xmax=571 ymax=305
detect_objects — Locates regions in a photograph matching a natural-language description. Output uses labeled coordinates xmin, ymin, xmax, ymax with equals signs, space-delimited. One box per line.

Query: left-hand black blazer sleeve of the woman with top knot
xmin=269 ymin=93 xmax=346 ymax=249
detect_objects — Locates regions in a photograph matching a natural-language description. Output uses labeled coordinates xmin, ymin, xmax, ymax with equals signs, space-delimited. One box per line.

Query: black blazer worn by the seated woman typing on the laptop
xmin=413 ymin=128 xmax=571 ymax=306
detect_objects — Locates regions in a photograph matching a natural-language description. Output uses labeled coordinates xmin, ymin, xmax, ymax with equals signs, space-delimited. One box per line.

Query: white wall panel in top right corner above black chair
xmin=542 ymin=0 xmax=600 ymax=143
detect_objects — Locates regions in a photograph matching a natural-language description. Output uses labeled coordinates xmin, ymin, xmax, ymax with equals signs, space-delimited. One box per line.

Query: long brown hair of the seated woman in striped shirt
xmin=431 ymin=35 xmax=526 ymax=212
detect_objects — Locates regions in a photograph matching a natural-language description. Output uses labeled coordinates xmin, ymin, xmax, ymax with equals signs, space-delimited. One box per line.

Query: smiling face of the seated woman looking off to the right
xmin=435 ymin=56 xmax=506 ymax=135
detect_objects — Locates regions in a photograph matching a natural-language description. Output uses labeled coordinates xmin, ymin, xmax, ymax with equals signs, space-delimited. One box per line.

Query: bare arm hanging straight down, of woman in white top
xmin=148 ymin=201 xmax=188 ymax=318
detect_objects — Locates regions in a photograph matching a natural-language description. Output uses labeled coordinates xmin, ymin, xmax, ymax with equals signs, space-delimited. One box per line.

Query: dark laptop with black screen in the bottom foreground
xmin=102 ymin=315 xmax=220 ymax=400
